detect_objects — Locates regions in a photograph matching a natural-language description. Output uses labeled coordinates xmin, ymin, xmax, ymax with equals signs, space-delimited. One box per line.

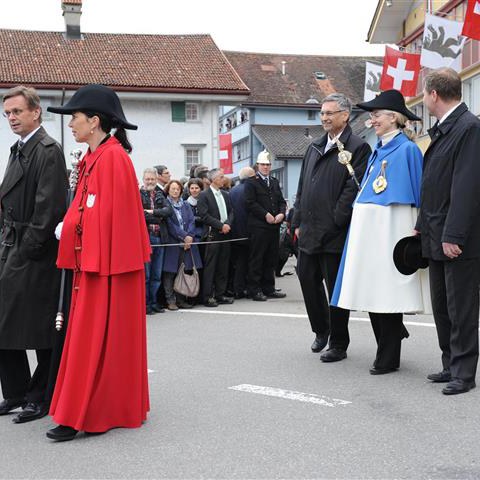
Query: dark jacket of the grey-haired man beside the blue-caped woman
xmin=292 ymin=125 xmax=371 ymax=255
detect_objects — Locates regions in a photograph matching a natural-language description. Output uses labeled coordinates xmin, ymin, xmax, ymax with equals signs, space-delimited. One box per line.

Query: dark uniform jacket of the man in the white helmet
xmin=245 ymin=174 xmax=287 ymax=232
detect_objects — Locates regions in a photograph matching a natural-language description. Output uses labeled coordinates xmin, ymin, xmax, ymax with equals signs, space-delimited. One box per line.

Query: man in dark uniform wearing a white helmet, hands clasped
xmin=245 ymin=150 xmax=287 ymax=301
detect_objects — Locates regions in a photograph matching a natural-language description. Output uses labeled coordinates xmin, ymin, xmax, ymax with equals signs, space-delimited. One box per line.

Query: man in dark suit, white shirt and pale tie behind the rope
xmin=197 ymin=168 xmax=233 ymax=307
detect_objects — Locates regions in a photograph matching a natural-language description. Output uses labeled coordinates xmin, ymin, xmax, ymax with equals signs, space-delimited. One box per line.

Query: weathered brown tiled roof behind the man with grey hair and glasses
xmin=224 ymin=51 xmax=382 ymax=105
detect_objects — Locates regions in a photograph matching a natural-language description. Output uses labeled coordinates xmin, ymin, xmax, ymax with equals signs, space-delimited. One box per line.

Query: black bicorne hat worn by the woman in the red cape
xmin=47 ymin=83 xmax=138 ymax=130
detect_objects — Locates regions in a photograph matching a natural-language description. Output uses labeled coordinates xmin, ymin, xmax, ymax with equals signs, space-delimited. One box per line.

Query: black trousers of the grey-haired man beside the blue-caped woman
xmin=297 ymin=251 xmax=350 ymax=344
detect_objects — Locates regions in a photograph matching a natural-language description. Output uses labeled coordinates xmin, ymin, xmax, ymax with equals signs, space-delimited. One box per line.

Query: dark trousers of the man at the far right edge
xmin=428 ymin=258 xmax=480 ymax=381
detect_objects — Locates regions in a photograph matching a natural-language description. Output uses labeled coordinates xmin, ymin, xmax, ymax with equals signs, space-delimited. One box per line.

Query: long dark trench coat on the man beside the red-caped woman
xmin=0 ymin=127 xmax=68 ymax=350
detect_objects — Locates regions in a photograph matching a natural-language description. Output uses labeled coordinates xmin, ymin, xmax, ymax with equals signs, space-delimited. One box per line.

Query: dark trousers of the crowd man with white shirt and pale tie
xmin=201 ymin=235 xmax=230 ymax=302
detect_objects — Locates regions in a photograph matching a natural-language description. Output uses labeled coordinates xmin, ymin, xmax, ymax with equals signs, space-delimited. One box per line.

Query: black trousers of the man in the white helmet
xmin=247 ymin=227 xmax=280 ymax=295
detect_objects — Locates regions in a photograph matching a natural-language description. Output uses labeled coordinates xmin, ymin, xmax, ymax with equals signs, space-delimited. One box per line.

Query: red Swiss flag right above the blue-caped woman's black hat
xmin=380 ymin=47 xmax=420 ymax=97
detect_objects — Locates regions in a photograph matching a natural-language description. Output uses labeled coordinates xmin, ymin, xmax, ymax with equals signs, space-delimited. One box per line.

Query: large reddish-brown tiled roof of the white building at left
xmin=0 ymin=29 xmax=248 ymax=94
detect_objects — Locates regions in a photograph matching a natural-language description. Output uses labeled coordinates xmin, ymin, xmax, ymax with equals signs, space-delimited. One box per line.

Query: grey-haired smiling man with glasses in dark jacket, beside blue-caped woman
xmin=292 ymin=93 xmax=371 ymax=356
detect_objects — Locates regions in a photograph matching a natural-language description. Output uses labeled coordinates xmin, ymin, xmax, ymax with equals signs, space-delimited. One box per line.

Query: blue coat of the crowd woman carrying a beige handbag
xmin=163 ymin=202 xmax=203 ymax=273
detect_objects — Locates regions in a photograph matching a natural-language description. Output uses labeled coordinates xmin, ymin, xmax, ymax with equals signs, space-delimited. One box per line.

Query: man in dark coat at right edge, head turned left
xmin=416 ymin=68 xmax=480 ymax=395
